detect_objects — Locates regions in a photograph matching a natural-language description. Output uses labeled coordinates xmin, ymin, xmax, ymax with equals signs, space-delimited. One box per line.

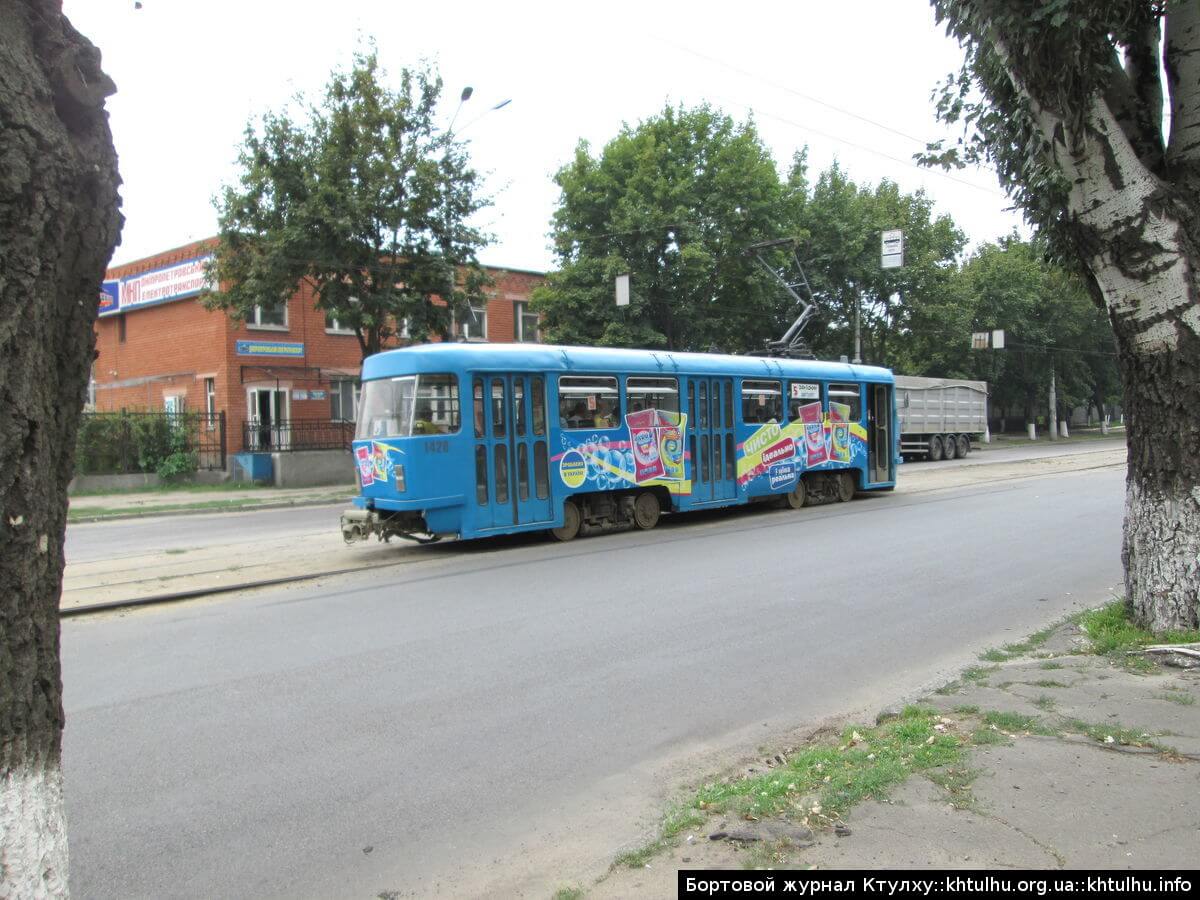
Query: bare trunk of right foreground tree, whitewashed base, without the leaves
xmin=1046 ymin=100 xmax=1200 ymax=631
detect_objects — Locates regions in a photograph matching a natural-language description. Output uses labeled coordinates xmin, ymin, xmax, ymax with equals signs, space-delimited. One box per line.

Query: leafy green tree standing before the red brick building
xmin=206 ymin=48 xmax=486 ymax=358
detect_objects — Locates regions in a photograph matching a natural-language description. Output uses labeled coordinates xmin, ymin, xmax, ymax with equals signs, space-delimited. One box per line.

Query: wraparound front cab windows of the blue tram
xmin=355 ymin=374 xmax=458 ymax=440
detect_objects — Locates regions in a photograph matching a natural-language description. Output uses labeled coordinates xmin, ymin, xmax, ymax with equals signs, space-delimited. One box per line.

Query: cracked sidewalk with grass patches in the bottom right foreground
xmin=585 ymin=607 xmax=1200 ymax=898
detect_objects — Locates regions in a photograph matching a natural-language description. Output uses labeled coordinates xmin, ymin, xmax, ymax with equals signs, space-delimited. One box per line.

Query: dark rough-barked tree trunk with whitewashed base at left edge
xmin=0 ymin=0 xmax=121 ymax=898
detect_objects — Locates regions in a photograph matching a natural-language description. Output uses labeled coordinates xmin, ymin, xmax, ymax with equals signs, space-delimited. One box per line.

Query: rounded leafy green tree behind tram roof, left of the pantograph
xmin=534 ymin=106 xmax=786 ymax=350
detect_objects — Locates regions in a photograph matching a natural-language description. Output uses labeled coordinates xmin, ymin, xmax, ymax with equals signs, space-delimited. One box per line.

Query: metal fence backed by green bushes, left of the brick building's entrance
xmin=76 ymin=412 xmax=226 ymax=476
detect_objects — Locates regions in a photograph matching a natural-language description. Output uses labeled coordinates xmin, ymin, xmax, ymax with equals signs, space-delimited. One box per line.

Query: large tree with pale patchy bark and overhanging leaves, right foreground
xmin=930 ymin=0 xmax=1200 ymax=630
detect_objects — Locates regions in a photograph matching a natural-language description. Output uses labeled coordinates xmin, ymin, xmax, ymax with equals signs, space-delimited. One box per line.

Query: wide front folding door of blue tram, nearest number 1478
xmin=472 ymin=374 xmax=554 ymax=528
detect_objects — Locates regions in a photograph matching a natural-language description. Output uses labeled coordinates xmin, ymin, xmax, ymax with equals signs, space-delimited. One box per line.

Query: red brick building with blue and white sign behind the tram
xmin=89 ymin=239 xmax=544 ymax=454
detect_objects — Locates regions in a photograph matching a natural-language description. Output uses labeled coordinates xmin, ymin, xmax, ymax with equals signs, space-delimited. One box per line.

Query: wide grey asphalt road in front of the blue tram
xmin=62 ymin=468 xmax=1123 ymax=898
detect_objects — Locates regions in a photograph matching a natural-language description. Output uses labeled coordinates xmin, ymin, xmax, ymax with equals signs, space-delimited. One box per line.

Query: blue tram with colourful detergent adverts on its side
xmin=342 ymin=343 xmax=900 ymax=541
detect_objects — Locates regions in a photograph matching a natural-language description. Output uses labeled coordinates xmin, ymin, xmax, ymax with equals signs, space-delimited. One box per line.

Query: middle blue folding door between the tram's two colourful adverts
xmin=688 ymin=378 xmax=738 ymax=503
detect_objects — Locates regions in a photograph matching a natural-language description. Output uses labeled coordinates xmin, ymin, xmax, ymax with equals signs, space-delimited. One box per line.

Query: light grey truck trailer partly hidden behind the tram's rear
xmin=895 ymin=374 xmax=988 ymax=461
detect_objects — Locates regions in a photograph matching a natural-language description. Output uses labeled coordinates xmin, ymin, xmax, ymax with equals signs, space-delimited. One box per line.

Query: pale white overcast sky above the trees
xmin=64 ymin=0 xmax=1020 ymax=270
